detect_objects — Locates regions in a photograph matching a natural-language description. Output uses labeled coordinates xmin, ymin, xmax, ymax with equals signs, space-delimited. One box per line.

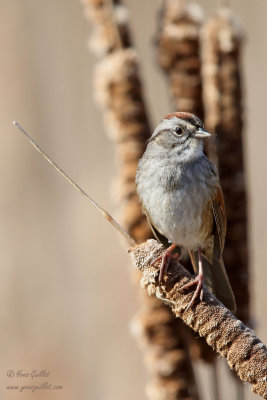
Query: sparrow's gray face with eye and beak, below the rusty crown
xmin=150 ymin=117 xmax=210 ymax=158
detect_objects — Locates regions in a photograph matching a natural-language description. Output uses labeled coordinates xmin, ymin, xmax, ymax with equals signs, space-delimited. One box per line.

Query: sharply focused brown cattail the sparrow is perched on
xmin=129 ymin=240 xmax=267 ymax=399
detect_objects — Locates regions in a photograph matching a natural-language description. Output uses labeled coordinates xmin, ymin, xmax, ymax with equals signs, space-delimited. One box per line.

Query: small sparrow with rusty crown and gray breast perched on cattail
xmin=136 ymin=112 xmax=236 ymax=311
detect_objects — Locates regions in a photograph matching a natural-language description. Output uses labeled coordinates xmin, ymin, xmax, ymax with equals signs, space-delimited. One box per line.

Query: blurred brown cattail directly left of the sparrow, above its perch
xmin=95 ymin=49 xmax=151 ymax=241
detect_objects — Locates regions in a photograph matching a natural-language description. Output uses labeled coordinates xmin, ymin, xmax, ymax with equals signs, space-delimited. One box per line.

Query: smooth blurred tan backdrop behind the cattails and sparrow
xmin=0 ymin=0 xmax=267 ymax=400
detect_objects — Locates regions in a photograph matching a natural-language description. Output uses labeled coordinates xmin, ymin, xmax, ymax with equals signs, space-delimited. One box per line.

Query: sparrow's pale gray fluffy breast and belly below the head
xmin=137 ymin=154 xmax=217 ymax=250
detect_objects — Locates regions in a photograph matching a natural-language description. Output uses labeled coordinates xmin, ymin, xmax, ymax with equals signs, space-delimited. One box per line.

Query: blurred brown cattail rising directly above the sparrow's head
xmin=157 ymin=0 xmax=203 ymax=119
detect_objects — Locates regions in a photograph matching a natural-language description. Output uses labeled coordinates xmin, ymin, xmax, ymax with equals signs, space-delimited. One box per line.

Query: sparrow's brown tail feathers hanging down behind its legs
xmin=189 ymin=251 xmax=236 ymax=312
